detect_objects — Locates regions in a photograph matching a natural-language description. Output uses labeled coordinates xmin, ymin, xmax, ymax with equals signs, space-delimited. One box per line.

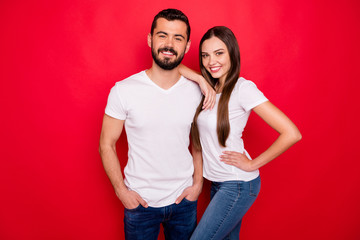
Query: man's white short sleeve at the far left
xmin=105 ymin=85 xmax=127 ymax=120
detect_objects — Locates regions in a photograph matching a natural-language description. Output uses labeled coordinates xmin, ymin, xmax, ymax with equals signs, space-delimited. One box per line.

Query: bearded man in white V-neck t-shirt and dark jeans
xmin=100 ymin=9 xmax=215 ymax=240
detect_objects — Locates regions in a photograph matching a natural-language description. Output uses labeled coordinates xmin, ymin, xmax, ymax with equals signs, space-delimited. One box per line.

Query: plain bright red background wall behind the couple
xmin=0 ymin=0 xmax=360 ymax=240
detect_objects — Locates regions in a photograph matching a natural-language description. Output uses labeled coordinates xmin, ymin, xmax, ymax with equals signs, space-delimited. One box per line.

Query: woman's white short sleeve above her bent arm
xmin=239 ymin=80 xmax=268 ymax=111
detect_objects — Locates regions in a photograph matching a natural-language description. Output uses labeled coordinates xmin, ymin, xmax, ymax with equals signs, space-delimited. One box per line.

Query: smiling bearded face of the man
xmin=148 ymin=18 xmax=190 ymax=70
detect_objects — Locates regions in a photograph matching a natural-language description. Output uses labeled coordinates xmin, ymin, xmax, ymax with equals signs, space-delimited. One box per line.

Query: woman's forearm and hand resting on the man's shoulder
xmin=178 ymin=64 xmax=216 ymax=109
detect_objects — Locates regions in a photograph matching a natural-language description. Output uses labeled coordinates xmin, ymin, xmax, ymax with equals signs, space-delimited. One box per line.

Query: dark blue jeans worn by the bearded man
xmin=124 ymin=198 xmax=197 ymax=240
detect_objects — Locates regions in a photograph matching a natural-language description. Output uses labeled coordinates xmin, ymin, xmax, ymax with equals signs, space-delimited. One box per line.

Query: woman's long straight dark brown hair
xmin=191 ymin=26 xmax=240 ymax=149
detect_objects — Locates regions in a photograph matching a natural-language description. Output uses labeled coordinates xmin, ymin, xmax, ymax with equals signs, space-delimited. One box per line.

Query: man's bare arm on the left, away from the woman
xmin=99 ymin=114 xmax=147 ymax=209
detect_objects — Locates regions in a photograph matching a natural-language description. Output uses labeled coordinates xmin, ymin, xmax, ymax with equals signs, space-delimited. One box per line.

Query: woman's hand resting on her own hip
xmin=220 ymin=151 xmax=256 ymax=172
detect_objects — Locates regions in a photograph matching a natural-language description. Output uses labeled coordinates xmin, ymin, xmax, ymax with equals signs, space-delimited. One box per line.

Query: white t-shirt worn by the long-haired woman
xmin=197 ymin=78 xmax=267 ymax=182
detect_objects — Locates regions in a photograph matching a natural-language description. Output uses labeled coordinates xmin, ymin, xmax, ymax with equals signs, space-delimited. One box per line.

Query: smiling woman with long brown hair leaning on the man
xmin=180 ymin=26 xmax=301 ymax=240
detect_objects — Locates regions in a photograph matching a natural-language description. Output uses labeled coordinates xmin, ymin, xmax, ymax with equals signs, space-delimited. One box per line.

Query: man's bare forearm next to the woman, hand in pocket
xmin=175 ymin=145 xmax=204 ymax=204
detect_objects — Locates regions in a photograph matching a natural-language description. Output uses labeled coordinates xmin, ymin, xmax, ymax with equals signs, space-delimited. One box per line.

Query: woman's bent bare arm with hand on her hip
xmin=220 ymin=101 xmax=302 ymax=172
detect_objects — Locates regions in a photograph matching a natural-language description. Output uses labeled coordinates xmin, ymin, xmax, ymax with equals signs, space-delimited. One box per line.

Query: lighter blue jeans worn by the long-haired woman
xmin=191 ymin=177 xmax=261 ymax=240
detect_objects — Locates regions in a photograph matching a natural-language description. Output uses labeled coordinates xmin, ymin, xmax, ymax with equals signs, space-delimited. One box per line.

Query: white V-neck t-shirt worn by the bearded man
xmin=105 ymin=71 xmax=201 ymax=207
